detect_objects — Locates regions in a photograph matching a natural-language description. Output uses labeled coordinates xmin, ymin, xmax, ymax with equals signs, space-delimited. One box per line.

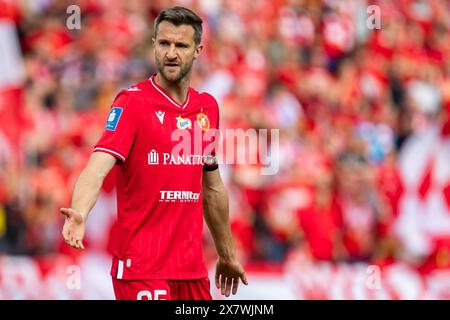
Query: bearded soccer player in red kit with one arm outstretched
xmin=61 ymin=7 xmax=247 ymax=300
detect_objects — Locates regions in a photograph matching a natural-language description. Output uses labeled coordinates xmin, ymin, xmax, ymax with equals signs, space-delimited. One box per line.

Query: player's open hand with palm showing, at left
xmin=60 ymin=208 xmax=86 ymax=249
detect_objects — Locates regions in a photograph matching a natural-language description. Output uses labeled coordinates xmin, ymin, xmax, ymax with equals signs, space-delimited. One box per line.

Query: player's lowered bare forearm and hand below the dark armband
xmin=202 ymin=169 xmax=247 ymax=297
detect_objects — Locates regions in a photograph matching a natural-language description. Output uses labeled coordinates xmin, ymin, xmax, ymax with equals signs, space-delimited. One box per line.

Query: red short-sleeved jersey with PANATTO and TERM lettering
xmin=94 ymin=76 xmax=219 ymax=280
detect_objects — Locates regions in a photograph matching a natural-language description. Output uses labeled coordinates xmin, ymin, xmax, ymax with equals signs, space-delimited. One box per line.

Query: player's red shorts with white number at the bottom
xmin=113 ymin=278 xmax=212 ymax=300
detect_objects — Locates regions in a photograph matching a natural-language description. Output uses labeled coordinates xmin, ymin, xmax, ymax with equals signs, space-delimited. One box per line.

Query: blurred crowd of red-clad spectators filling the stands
xmin=0 ymin=0 xmax=450 ymax=276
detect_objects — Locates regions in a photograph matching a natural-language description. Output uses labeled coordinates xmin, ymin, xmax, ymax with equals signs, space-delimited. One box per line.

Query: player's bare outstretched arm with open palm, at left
xmin=60 ymin=152 xmax=116 ymax=249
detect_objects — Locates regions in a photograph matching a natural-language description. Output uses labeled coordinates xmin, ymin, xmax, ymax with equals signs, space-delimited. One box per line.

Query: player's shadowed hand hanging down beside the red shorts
xmin=216 ymin=258 xmax=248 ymax=297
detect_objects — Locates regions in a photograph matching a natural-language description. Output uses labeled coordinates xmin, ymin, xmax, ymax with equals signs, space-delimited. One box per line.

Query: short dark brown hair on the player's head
xmin=153 ymin=6 xmax=203 ymax=44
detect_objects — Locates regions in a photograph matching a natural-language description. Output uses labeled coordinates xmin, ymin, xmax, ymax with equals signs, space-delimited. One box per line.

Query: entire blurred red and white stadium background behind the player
xmin=0 ymin=0 xmax=450 ymax=299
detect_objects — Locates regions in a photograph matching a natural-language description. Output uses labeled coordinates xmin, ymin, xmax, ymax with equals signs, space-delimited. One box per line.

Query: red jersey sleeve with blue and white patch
xmin=94 ymin=93 xmax=136 ymax=162
